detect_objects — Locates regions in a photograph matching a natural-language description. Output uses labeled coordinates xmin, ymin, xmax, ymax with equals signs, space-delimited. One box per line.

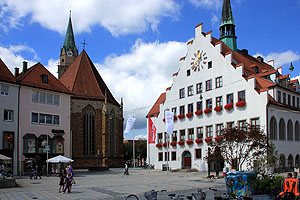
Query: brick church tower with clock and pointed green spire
xmin=58 ymin=11 xmax=78 ymax=79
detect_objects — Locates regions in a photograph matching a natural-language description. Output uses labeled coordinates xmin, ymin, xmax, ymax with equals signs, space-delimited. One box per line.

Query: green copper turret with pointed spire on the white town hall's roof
xmin=219 ymin=0 xmax=237 ymax=52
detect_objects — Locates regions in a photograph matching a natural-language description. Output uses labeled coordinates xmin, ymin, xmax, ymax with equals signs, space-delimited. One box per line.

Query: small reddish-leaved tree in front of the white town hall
xmin=205 ymin=124 xmax=268 ymax=171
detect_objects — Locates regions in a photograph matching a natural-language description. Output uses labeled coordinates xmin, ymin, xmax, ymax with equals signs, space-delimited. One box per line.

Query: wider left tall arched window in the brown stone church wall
xmin=83 ymin=106 xmax=95 ymax=155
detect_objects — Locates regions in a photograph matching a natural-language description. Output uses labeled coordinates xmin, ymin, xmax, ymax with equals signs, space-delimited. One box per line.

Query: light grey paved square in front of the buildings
xmin=0 ymin=168 xmax=225 ymax=200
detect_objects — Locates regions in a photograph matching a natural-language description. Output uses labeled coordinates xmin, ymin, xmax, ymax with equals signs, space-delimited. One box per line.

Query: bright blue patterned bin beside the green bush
xmin=225 ymin=171 xmax=257 ymax=198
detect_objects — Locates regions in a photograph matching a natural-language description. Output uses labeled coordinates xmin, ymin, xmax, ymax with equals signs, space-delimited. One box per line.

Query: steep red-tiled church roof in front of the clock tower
xmin=59 ymin=50 xmax=119 ymax=106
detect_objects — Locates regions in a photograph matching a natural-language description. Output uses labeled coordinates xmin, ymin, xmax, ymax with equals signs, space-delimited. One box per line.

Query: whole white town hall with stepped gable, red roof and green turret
xmin=147 ymin=0 xmax=300 ymax=171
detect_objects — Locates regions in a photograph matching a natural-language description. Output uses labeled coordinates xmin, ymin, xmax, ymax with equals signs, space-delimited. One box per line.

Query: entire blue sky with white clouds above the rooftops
xmin=0 ymin=0 xmax=300 ymax=138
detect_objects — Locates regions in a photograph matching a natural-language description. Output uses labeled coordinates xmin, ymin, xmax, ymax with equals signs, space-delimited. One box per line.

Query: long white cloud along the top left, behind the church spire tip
xmin=0 ymin=0 xmax=180 ymax=36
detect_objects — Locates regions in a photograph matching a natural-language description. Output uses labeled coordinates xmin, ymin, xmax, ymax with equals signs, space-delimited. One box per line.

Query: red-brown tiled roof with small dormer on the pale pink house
xmin=16 ymin=62 xmax=71 ymax=94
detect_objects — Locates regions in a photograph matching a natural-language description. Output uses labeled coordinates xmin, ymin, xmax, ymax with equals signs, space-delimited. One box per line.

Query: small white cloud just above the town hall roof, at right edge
xmin=254 ymin=50 xmax=300 ymax=68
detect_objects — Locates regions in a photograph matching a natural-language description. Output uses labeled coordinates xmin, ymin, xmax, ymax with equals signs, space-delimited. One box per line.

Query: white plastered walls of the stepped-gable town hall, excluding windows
xmin=147 ymin=24 xmax=300 ymax=171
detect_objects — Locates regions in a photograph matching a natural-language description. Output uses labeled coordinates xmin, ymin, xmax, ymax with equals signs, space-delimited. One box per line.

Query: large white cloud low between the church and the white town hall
xmin=96 ymin=40 xmax=186 ymax=129
